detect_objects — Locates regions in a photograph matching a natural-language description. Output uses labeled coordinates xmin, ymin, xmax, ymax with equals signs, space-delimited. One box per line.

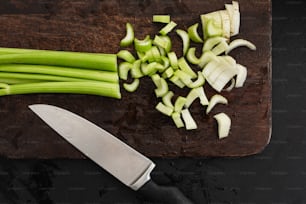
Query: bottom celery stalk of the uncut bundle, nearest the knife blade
xmin=0 ymin=81 xmax=121 ymax=99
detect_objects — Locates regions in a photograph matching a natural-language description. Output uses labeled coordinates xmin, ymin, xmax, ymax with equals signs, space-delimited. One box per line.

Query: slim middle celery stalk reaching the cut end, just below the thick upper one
xmin=0 ymin=64 xmax=119 ymax=82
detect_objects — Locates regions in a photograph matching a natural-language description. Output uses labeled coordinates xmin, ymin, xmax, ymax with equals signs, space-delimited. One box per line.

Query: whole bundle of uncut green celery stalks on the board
xmin=0 ymin=48 xmax=121 ymax=98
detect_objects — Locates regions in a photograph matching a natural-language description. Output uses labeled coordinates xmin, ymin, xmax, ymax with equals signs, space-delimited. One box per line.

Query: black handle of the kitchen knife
xmin=138 ymin=180 xmax=193 ymax=204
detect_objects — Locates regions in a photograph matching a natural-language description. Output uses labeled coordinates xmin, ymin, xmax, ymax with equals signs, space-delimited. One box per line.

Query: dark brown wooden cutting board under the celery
xmin=0 ymin=0 xmax=272 ymax=158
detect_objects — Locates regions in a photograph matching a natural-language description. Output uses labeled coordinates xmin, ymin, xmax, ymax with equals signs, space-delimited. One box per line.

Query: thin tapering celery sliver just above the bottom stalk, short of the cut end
xmin=0 ymin=72 xmax=92 ymax=84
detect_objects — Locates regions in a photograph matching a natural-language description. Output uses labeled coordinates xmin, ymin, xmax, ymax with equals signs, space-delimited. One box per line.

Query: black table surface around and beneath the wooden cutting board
xmin=0 ymin=0 xmax=306 ymax=204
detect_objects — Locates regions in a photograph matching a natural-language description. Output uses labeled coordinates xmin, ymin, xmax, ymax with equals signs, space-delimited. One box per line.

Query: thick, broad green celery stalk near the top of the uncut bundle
xmin=0 ymin=51 xmax=117 ymax=72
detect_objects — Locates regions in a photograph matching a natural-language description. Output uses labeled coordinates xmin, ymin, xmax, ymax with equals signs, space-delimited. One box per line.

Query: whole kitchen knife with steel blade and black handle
xmin=29 ymin=104 xmax=192 ymax=204
